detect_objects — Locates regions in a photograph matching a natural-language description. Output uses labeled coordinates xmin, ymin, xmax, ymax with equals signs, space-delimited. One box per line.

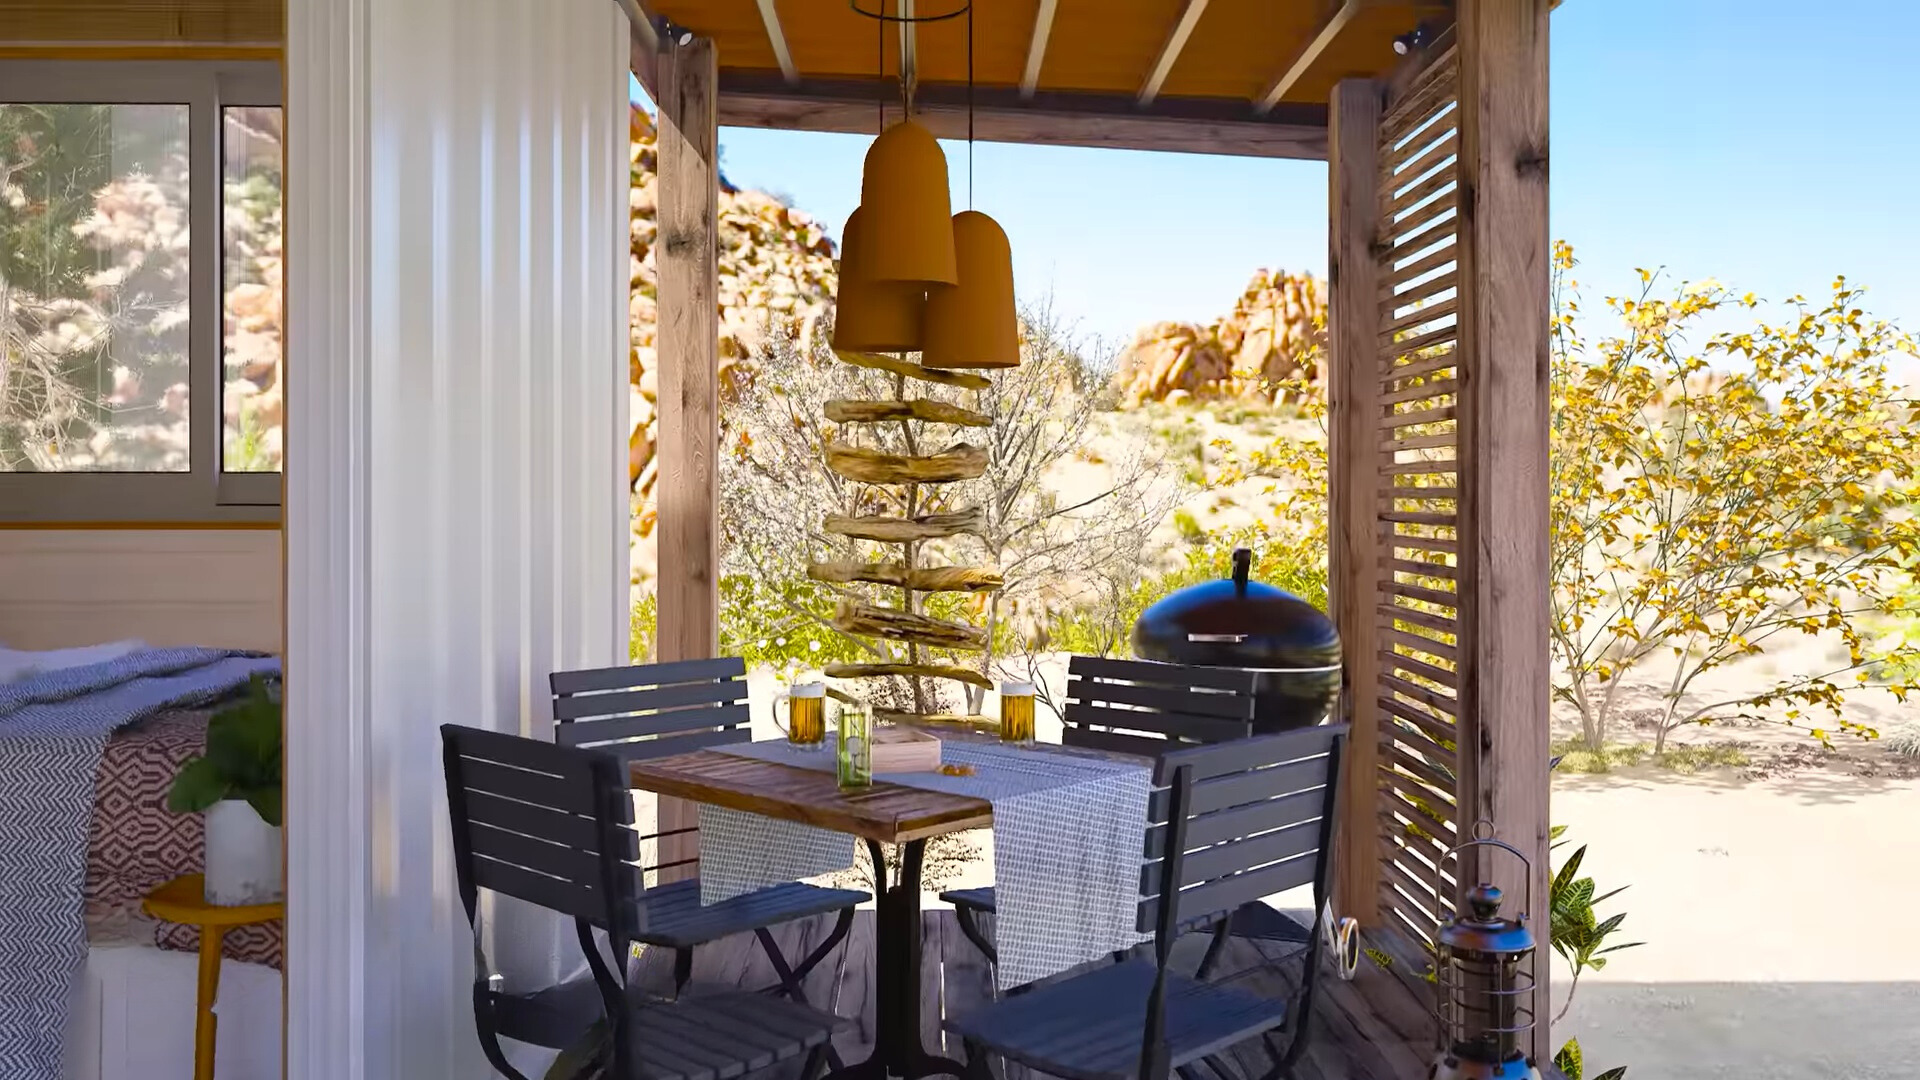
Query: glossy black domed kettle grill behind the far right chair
xmin=1133 ymin=548 xmax=1340 ymax=734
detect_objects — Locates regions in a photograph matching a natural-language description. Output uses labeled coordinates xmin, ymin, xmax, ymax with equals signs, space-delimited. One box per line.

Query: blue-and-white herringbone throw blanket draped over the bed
xmin=0 ymin=650 xmax=280 ymax=1080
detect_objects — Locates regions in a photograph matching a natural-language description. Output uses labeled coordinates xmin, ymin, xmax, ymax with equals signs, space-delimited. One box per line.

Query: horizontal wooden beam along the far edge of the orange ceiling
xmin=720 ymin=71 xmax=1327 ymax=161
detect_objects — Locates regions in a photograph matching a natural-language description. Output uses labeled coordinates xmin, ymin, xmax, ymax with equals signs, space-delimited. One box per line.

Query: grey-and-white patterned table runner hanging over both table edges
xmin=699 ymin=740 xmax=1150 ymax=990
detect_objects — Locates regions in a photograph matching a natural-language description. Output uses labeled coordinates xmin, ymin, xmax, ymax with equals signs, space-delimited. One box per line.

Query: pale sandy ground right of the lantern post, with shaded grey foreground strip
xmin=1553 ymin=626 xmax=1920 ymax=1080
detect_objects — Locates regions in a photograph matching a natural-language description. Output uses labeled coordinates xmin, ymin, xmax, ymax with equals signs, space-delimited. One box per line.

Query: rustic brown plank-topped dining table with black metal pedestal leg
xmin=630 ymin=749 xmax=993 ymax=1080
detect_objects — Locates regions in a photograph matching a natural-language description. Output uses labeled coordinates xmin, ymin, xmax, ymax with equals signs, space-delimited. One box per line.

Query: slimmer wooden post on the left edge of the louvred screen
xmin=1327 ymin=79 xmax=1380 ymax=926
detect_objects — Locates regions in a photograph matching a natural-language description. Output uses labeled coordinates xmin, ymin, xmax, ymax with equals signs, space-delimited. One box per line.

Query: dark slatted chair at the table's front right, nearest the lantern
xmin=947 ymin=724 xmax=1346 ymax=1080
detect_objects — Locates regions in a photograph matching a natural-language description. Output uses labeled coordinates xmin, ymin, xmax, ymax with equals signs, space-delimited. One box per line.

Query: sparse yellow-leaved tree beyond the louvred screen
xmin=1212 ymin=244 xmax=1920 ymax=753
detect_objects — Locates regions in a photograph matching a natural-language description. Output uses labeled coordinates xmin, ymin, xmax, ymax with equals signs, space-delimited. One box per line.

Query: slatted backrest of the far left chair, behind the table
xmin=549 ymin=657 xmax=753 ymax=761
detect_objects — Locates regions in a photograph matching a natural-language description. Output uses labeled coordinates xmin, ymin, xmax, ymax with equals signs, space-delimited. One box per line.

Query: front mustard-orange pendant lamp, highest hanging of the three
xmin=860 ymin=119 xmax=960 ymax=284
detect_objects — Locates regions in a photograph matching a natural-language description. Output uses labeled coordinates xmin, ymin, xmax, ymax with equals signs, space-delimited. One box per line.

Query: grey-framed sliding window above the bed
xmin=0 ymin=61 xmax=282 ymax=521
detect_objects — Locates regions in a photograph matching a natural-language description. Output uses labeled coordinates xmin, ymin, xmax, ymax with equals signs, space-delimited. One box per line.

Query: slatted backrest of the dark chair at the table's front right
xmin=1139 ymin=724 xmax=1348 ymax=932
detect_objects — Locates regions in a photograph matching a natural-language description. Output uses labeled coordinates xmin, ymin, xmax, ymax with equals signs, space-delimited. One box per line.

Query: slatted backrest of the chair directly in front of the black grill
xmin=1060 ymin=655 xmax=1260 ymax=757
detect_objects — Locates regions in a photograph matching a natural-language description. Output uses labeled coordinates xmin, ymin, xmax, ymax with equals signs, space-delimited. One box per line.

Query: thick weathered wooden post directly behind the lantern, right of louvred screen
xmin=1457 ymin=0 xmax=1551 ymax=1061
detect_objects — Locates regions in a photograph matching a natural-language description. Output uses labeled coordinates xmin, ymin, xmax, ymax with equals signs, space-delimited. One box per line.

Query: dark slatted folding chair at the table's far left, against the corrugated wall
xmin=549 ymin=657 xmax=872 ymax=1001
